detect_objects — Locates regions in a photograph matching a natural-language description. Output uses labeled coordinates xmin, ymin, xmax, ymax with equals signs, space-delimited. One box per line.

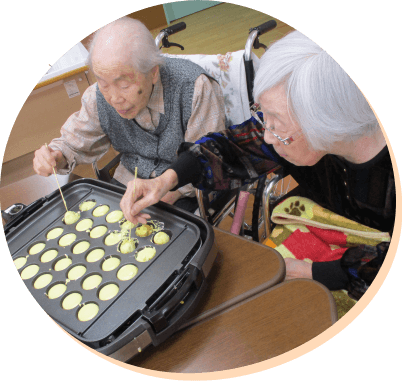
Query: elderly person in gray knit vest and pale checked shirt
xmin=33 ymin=17 xmax=225 ymax=211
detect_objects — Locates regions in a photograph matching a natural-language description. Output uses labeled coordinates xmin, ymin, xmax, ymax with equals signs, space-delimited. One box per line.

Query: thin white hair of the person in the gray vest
xmin=86 ymin=16 xmax=165 ymax=74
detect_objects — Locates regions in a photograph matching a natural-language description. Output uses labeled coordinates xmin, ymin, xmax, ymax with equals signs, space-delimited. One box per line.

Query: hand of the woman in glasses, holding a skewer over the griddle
xmin=120 ymin=169 xmax=177 ymax=224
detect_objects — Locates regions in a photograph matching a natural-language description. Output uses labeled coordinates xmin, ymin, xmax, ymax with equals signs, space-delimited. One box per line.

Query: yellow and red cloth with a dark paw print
xmin=264 ymin=196 xmax=390 ymax=262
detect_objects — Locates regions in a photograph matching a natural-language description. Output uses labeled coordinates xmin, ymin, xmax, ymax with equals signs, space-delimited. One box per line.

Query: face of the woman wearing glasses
xmin=259 ymin=84 xmax=326 ymax=166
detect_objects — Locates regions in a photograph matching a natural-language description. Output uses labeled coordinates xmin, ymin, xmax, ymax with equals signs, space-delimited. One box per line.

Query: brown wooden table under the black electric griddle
xmin=0 ymin=175 xmax=337 ymax=373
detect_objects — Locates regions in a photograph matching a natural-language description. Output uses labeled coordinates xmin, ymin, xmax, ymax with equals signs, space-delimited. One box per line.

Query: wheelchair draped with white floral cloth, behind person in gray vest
xmin=92 ymin=20 xmax=287 ymax=242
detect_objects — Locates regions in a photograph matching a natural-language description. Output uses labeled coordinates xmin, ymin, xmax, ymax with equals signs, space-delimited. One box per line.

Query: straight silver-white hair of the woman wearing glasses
xmin=254 ymin=31 xmax=380 ymax=150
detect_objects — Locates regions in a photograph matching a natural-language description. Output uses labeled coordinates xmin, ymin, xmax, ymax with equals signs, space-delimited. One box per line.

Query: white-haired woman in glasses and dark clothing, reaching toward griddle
xmin=121 ymin=31 xmax=396 ymax=296
